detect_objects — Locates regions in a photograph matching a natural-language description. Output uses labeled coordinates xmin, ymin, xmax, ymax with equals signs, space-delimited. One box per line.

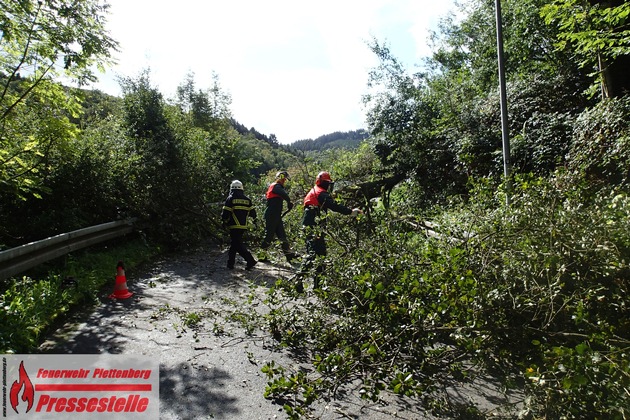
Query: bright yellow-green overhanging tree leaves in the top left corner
xmin=0 ymin=0 xmax=117 ymax=197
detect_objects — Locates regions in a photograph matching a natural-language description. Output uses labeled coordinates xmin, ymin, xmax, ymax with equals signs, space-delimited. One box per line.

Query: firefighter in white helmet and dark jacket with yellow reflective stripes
xmin=221 ymin=180 xmax=258 ymax=270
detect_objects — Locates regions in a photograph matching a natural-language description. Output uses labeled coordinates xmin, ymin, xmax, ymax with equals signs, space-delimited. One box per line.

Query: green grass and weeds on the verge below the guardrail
xmin=0 ymin=238 xmax=160 ymax=353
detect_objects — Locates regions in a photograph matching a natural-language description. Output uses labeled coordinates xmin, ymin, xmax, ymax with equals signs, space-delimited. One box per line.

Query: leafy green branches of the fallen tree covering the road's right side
xmin=267 ymin=170 xmax=630 ymax=418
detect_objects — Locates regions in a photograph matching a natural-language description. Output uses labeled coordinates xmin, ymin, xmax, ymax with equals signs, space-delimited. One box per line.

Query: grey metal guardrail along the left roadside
xmin=0 ymin=219 xmax=136 ymax=279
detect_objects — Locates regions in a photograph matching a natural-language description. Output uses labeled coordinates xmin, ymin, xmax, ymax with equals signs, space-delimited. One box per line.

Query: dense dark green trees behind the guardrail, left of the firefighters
xmin=0 ymin=67 xmax=268 ymax=246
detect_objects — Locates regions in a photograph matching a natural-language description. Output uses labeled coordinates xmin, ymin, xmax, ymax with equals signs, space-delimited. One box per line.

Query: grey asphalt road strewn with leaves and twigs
xmin=41 ymin=249 xmax=512 ymax=420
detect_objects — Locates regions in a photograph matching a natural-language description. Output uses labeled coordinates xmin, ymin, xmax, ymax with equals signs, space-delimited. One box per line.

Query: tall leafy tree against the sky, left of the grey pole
xmin=364 ymin=41 xmax=465 ymax=204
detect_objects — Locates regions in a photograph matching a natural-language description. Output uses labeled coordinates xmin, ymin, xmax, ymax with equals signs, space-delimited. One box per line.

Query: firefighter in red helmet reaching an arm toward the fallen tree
xmin=296 ymin=172 xmax=363 ymax=293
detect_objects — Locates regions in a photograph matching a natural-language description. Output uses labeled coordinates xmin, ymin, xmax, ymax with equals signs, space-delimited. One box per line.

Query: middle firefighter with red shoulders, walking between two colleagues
xmin=258 ymin=171 xmax=297 ymax=262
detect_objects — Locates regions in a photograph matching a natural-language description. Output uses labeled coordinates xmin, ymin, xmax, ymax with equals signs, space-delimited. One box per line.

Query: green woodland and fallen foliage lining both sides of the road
xmin=0 ymin=0 xmax=630 ymax=419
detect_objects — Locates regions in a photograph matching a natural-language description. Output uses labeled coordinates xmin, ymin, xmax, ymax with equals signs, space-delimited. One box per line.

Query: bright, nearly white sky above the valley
xmin=93 ymin=0 xmax=454 ymax=143
